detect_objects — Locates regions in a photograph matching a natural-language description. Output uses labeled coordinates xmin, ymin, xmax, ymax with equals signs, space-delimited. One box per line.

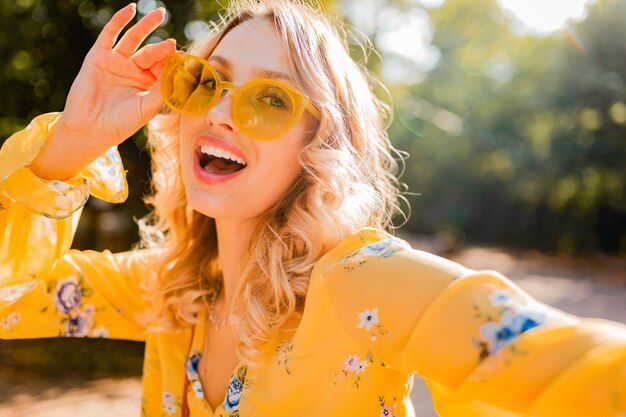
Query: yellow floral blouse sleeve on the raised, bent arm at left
xmin=0 ymin=113 xmax=153 ymax=340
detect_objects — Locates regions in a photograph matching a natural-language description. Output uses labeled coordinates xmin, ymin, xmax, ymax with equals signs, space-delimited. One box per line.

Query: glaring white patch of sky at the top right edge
xmin=498 ymin=0 xmax=596 ymax=33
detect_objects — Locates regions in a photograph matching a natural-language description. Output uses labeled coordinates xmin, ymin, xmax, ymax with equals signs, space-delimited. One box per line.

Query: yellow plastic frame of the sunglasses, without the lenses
xmin=161 ymin=51 xmax=321 ymax=140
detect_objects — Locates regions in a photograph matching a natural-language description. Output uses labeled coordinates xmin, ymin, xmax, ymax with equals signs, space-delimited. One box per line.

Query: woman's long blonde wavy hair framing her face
xmin=138 ymin=0 xmax=406 ymax=365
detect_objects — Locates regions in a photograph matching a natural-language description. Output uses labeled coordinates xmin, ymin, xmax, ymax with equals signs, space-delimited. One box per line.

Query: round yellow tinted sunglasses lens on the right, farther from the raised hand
xmin=235 ymin=83 xmax=294 ymax=139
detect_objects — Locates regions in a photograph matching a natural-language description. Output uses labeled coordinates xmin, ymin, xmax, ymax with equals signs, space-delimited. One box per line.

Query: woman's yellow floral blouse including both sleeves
xmin=0 ymin=113 xmax=626 ymax=417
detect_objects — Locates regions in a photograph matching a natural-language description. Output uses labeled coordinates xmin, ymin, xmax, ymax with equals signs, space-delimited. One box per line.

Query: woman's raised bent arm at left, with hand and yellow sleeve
xmin=0 ymin=3 xmax=176 ymax=339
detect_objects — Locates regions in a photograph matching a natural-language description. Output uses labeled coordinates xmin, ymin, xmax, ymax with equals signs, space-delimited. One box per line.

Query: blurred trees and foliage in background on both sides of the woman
xmin=0 ymin=0 xmax=626 ymax=254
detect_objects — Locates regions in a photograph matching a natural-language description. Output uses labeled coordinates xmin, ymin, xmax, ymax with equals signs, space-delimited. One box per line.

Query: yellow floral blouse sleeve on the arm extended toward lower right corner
xmin=318 ymin=228 xmax=626 ymax=417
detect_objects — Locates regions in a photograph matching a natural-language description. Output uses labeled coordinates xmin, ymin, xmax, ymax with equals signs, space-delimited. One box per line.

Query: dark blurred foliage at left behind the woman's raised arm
xmin=0 ymin=0 xmax=225 ymax=251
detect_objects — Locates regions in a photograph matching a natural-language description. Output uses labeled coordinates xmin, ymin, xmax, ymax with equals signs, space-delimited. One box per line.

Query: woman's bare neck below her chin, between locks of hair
xmin=215 ymin=219 xmax=256 ymax=314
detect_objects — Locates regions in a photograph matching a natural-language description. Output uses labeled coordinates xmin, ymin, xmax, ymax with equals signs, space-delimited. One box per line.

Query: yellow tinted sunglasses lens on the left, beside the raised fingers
xmin=161 ymin=58 xmax=217 ymax=113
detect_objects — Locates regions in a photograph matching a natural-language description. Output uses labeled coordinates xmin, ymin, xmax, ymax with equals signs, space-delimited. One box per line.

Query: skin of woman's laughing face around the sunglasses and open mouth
xmin=180 ymin=19 xmax=314 ymax=220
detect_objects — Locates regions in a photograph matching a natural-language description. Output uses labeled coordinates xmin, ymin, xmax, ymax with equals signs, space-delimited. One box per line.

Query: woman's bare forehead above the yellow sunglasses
xmin=211 ymin=18 xmax=289 ymax=73
